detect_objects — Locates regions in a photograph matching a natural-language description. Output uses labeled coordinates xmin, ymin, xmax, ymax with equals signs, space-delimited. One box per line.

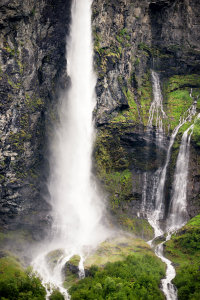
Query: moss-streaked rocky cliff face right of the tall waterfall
xmin=93 ymin=0 xmax=200 ymax=226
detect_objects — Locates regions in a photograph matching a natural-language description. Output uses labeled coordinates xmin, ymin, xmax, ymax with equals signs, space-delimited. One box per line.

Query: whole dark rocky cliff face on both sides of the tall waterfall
xmin=0 ymin=0 xmax=200 ymax=240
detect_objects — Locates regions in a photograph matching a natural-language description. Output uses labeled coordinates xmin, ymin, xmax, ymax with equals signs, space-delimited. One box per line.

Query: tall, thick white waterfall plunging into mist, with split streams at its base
xmin=33 ymin=0 xmax=106 ymax=299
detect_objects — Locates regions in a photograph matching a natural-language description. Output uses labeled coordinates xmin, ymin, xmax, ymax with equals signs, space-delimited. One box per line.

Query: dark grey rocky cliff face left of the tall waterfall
xmin=0 ymin=0 xmax=71 ymax=240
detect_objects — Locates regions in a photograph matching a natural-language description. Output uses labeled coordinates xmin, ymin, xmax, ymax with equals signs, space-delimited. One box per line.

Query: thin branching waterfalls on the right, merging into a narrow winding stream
xmin=142 ymin=77 xmax=197 ymax=300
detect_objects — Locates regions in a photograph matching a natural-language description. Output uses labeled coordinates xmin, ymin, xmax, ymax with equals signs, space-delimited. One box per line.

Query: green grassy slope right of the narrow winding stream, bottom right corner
xmin=166 ymin=215 xmax=200 ymax=300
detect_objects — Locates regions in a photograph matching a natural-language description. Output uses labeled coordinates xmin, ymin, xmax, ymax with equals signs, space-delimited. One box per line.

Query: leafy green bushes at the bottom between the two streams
xmin=69 ymin=254 xmax=165 ymax=300
